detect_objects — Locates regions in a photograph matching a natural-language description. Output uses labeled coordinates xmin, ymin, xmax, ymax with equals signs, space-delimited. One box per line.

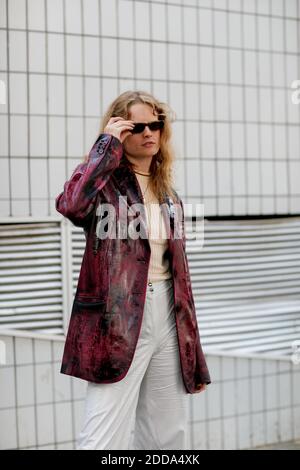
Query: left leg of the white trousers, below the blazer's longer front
xmin=77 ymin=288 xmax=153 ymax=450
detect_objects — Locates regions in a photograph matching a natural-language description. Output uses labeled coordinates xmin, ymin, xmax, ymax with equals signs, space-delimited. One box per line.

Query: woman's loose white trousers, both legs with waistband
xmin=77 ymin=279 xmax=189 ymax=450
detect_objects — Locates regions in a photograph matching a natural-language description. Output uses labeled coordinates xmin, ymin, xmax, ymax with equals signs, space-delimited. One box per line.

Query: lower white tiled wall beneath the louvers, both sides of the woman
xmin=0 ymin=331 xmax=300 ymax=450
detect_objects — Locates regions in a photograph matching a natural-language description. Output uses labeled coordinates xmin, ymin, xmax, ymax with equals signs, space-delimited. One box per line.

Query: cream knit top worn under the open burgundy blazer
xmin=135 ymin=172 xmax=172 ymax=282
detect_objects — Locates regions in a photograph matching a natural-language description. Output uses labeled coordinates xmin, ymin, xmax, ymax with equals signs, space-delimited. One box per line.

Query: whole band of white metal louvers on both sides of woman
xmin=4 ymin=217 xmax=300 ymax=354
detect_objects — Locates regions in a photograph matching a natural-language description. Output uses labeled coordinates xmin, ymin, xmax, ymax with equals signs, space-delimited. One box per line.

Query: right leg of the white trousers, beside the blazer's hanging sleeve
xmin=133 ymin=283 xmax=190 ymax=450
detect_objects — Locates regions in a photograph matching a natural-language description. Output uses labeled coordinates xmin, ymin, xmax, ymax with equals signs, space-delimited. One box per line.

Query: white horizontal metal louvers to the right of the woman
xmin=186 ymin=217 xmax=300 ymax=355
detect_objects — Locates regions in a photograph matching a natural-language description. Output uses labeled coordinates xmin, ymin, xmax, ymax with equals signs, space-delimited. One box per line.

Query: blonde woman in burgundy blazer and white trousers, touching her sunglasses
xmin=56 ymin=91 xmax=210 ymax=450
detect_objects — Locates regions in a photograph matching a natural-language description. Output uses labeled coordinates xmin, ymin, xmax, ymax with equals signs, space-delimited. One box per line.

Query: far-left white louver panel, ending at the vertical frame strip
xmin=0 ymin=222 xmax=63 ymax=333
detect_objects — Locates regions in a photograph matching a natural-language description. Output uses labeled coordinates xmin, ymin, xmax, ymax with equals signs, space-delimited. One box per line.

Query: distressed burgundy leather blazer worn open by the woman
xmin=55 ymin=134 xmax=211 ymax=393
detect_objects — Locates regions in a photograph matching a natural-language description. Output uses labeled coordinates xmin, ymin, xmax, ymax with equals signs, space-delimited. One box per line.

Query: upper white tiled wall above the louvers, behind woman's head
xmin=0 ymin=0 xmax=300 ymax=216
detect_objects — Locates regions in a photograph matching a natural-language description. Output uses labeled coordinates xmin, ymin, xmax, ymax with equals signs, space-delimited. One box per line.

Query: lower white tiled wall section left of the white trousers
xmin=0 ymin=332 xmax=86 ymax=449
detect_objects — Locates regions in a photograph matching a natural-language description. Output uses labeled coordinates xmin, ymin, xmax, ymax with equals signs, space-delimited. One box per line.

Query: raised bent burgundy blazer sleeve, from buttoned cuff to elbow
xmin=55 ymin=134 xmax=123 ymax=227
